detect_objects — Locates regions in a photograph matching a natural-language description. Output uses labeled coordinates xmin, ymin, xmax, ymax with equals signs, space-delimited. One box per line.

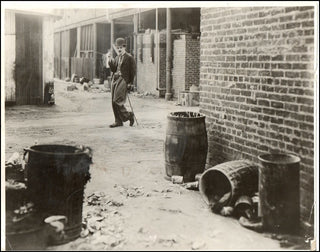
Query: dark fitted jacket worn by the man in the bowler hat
xmin=109 ymin=53 xmax=136 ymax=84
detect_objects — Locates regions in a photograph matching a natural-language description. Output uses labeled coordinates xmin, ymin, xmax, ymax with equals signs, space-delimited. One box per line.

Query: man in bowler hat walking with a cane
xmin=107 ymin=38 xmax=136 ymax=128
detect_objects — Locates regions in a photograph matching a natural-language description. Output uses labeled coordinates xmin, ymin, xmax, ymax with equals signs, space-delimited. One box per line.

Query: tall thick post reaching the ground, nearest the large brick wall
xmin=165 ymin=8 xmax=172 ymax=101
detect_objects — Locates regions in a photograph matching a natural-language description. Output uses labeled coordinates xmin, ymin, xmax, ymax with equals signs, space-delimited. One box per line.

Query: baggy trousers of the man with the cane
xmin=111 ymin=76 xmax=131 ymax=124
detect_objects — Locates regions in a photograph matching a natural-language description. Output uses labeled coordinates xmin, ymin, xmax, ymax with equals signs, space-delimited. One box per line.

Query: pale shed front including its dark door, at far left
xmin=4 ymin=10 xmax=55 ymax=105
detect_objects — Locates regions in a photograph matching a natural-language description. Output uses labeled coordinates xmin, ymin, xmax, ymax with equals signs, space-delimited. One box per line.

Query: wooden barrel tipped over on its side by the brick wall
xmin=199 ymin=160 xmax=258 ymax=206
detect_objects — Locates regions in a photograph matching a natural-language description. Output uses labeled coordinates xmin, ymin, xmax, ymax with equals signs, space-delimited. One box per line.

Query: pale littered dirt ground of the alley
xmin=5 ymin=81 xmax=288 ymax=250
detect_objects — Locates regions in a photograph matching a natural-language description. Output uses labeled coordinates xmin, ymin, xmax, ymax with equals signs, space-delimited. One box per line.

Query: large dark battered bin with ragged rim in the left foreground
xmin=25 ymin=145 xmax=91 ymax=244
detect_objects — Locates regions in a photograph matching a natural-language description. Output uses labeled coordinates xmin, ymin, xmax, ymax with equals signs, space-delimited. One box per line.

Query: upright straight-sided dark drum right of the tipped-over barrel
xmin=258 ymin=154 xmax=300 ymax=233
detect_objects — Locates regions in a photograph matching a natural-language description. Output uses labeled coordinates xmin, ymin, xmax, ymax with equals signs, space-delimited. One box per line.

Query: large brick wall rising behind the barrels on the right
xmin=200 ymin=7 xmax=314 ymax=232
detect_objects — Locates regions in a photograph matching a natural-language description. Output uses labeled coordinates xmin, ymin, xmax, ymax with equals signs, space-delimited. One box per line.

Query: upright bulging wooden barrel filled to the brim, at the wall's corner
xmin=164 ymin=112 xmax=208 ymax=182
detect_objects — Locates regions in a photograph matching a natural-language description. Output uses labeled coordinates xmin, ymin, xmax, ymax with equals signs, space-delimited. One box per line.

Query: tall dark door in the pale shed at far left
xmin=15 ymin=14 xmax=43 ymax=105
